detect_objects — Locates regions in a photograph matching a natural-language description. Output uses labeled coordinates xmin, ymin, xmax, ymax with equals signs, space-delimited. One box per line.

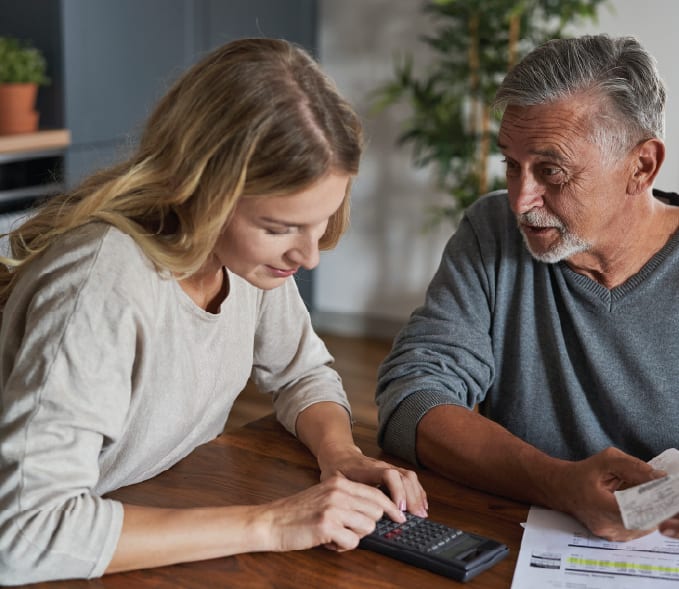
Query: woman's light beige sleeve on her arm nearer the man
xmin=253 ymin=279 xmax=351 ymax=434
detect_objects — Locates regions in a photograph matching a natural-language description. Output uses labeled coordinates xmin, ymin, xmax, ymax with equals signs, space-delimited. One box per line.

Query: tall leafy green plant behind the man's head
xmin=373 ymin=0 xmax=607 ymax=225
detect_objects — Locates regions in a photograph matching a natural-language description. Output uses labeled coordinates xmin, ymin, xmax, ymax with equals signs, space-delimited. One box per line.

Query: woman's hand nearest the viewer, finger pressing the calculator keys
xmin=257 ymin=475 xmax=405 ymax=551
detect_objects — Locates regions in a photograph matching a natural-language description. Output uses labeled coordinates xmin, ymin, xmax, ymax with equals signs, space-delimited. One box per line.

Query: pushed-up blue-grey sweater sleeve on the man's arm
xmin=376 ymin=209 xmax=494 ymax=463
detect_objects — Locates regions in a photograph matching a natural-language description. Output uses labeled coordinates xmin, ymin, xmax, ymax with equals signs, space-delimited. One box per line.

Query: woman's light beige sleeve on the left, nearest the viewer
xmin=0 ymin=227 xmax=140 ymax=584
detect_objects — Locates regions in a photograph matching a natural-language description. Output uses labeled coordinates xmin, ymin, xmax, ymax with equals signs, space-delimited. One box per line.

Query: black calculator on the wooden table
xmin=359 ymin=513 xmax=509 ymax=581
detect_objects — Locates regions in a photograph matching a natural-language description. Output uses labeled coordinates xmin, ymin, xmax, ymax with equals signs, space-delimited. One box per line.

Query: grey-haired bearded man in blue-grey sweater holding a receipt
xmin=376 ymin=35 xmax=679 ymax=540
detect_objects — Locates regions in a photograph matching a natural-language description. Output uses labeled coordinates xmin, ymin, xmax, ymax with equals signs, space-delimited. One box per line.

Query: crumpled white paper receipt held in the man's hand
xmin=615 ymin=448 xmax=679 ymax=530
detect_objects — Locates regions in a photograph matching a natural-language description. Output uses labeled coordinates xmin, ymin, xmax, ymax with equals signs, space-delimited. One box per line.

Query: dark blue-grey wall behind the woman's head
xmin=0 ymin=0 xmax=317 ymax=305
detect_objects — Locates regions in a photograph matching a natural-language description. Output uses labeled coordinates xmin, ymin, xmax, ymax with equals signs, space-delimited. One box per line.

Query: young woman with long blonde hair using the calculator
xmin=0 ymin=39 xmax=426 ymax=584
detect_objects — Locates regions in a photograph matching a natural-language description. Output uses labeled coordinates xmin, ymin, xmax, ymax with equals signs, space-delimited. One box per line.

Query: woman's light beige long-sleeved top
xmin=0 ymin=224 xmax=348 ymax=584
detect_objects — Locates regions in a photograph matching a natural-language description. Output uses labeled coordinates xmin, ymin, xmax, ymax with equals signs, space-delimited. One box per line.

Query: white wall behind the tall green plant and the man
xmin=314 ymin=0 xmax=679 ymax=336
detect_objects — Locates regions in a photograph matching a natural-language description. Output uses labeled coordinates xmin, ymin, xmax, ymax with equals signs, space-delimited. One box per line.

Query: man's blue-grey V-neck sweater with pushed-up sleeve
xmin=376 ymin=193 xmax=679 ymax=462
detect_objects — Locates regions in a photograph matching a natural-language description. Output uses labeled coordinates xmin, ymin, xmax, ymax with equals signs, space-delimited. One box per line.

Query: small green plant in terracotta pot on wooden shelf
xmin=0 ymin=37 xmax=49 ymax=135
